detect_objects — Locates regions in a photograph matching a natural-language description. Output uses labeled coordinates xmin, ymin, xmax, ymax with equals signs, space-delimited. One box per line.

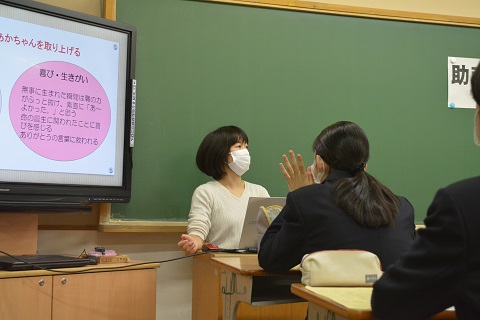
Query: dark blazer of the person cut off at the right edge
xmin=372 ymin=177 xmax=480 ymax=319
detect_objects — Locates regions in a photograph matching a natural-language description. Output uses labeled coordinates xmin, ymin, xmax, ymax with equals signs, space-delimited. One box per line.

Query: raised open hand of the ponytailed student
xmin=280 ymin=150 xmax=313 ymax=191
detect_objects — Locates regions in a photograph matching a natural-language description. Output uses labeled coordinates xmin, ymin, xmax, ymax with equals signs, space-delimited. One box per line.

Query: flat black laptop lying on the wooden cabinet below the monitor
xmin=0 ymin=255 xmax=91 ymax=271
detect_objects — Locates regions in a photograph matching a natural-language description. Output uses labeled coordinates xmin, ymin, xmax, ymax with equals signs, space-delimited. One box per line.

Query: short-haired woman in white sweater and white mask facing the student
xmin=178 ymin=126 xmax=269 ymax=253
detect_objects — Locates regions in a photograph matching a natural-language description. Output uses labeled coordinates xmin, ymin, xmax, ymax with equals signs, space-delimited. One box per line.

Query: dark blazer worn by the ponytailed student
xmin=258 ymin=170 xmax=415 ymax=273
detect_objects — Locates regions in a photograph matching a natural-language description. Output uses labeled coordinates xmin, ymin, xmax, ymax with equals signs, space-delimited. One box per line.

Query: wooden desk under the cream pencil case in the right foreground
xmin=291 ymin=283 xmax=456 ymax=320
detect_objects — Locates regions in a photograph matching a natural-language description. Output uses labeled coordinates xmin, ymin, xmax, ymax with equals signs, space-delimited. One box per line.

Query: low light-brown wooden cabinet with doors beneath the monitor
xmin=0 ymin=261 xmax=160 ymax=320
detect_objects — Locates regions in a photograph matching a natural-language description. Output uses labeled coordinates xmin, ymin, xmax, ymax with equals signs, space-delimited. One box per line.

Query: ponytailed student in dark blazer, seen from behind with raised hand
xmin=258 ymin=121 xmax=415 ymax=272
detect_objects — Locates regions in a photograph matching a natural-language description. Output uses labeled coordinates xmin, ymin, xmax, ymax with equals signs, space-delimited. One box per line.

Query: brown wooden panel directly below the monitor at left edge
xmin=0 ymin=213 xmax=38 ymax=255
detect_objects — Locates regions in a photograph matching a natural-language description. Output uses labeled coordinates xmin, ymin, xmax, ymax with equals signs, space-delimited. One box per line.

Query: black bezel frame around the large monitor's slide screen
xmin=0 ymin=0 xmax=137 ymax=208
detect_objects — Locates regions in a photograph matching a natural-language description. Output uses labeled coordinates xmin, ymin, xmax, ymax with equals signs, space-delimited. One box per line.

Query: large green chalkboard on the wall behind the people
xmin=111 ymin=0 xmax=480 ymax=223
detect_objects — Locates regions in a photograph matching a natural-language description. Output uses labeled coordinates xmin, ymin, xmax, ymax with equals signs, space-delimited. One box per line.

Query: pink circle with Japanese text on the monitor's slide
xmin=9 ymin=61 xmax=111 ymax=161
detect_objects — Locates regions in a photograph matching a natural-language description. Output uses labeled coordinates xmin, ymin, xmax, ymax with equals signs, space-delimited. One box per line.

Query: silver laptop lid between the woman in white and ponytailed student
xmin=239 ymin=197 xmax=286 ymax=249
